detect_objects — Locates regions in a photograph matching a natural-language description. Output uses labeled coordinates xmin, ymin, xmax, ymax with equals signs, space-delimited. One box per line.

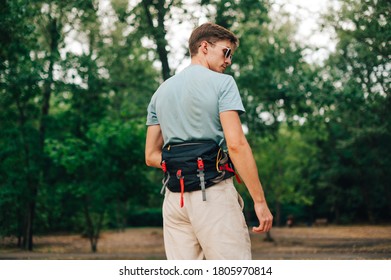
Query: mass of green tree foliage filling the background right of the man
xmin=231 ymin=1 xmax=391 ymax=224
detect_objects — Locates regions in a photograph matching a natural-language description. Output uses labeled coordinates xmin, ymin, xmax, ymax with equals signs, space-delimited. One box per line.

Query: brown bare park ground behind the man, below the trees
xmin=0 ymin=225 xmax=391 ymax=260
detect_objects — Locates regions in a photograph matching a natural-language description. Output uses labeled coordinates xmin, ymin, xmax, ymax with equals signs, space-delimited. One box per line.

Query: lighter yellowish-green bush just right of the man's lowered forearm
xmin=254 ymin=125 xmax=317 ymax=226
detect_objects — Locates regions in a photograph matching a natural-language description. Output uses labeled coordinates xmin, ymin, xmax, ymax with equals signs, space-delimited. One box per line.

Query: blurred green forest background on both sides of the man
xmin=0 ymin=0 xmax=391 ymax=251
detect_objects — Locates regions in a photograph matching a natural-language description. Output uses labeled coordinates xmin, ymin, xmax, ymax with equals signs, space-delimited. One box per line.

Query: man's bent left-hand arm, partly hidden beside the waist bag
xmin=145 ymin=125 xmax=164 ymax=168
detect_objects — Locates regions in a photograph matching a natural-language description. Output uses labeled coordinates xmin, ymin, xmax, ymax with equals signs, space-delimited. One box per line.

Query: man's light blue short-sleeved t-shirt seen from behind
xmin=147 ymin=64 xmax=245 ymax=146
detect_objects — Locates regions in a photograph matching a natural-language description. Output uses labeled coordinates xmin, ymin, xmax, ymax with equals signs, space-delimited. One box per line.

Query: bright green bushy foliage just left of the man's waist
xmin=46 ymin=119 xmax=150 ymax=232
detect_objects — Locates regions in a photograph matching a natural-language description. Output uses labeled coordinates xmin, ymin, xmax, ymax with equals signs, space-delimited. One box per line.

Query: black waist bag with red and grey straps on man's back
xmin=161 ymin=141 xmax=238 ymax=207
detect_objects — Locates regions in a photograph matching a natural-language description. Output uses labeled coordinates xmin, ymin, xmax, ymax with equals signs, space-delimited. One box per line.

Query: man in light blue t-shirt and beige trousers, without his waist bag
xmin=145 ymin=23 xmax=273 ymax=259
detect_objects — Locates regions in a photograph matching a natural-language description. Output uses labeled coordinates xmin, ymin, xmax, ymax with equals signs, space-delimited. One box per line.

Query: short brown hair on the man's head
xmin=189 ymin=22 xmax=239 ymax=57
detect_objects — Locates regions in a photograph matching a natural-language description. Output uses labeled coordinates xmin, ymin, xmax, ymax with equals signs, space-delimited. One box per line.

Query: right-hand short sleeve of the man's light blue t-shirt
xmin=219 ymin=76 xmax=245 ymax=114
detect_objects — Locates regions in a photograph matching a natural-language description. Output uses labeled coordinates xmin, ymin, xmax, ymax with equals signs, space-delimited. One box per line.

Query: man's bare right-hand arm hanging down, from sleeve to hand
xmin=220 ymin=111 xmax=273 ymax=232
